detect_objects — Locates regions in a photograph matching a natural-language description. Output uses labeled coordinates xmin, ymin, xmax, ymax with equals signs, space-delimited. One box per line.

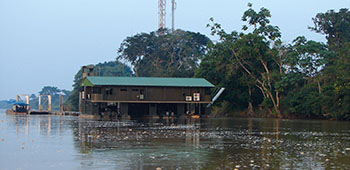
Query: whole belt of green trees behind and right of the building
xmin=67 ymin=4 xmax=350 ymax=120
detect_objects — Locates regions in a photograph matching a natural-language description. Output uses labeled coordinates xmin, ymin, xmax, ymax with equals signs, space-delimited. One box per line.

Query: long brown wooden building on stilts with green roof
xmin=80 ymin=73 xmax=214 ymax=116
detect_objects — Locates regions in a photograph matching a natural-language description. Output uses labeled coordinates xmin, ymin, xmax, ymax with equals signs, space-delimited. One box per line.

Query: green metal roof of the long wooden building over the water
xmin=81 ymin=76 xmax=215 ymax=87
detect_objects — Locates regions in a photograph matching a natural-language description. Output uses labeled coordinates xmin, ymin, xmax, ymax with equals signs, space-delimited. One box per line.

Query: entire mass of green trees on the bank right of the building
xmin=196 ymin=4 xmax=350 ymax=120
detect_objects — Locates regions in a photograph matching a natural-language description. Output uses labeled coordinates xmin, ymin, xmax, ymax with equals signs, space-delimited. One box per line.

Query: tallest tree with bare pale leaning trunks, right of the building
xmin=212 ymin=4 xmax=283 ymax=117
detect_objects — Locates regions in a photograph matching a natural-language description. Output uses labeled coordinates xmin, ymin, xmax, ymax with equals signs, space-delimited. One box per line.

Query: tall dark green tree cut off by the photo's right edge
xmin=310 ymin=8 xmax=350 ymax=120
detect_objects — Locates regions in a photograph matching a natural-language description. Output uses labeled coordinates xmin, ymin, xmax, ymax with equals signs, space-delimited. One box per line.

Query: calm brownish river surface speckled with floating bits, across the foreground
xmin=0 ymin=110 xmax=350 ymax=170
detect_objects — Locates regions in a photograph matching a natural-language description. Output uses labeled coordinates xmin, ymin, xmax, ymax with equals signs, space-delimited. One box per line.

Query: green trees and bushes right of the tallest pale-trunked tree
xmin=282 ymin=9 xmax=350 ymax=120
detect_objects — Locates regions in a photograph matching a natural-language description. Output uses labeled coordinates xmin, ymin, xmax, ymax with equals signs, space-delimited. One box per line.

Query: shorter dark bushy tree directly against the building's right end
xmin=195 ymin=35 xmax=261 ymax=112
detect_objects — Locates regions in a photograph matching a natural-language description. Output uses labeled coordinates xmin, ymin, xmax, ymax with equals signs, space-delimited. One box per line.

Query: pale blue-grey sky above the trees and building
xmin=0 ymin=0 xmax=350 ymax=100
